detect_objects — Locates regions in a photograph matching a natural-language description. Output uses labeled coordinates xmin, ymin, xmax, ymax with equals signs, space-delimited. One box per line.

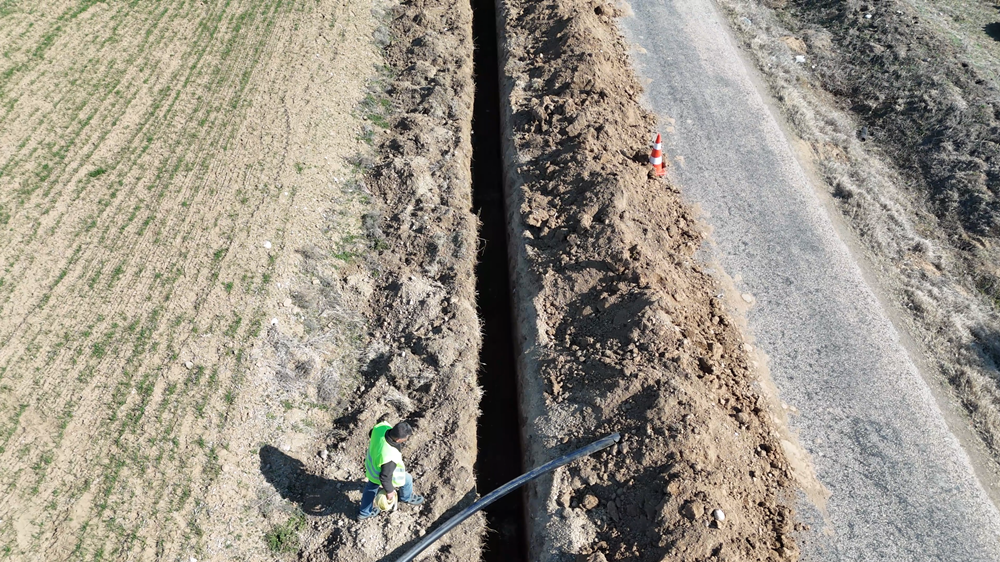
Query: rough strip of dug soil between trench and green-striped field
xmin=296 ymin=0 xmax=485 ymax=562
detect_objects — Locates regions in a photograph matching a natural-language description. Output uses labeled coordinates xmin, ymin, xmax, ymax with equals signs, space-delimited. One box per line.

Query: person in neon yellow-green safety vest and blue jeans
xmin=358 ymin=421 xmax=424 ymax=521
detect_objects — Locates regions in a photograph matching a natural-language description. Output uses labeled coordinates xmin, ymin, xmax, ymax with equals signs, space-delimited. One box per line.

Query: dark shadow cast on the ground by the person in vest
xmin=260 ymin=445 xmax=361 ymax=516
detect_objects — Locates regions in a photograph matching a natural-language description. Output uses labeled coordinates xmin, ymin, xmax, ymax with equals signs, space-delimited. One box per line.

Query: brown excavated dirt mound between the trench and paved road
xmin=499 ymin=0 xmax=798 ymax=562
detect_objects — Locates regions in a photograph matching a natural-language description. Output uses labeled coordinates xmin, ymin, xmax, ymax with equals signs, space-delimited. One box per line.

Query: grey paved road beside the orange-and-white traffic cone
xmin=622 ymin=0 xmax=1000 ymax=561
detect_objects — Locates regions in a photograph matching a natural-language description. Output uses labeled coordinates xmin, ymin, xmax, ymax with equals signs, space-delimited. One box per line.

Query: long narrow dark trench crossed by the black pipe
xmin=472 ymin=0 xmax=527 ymax=562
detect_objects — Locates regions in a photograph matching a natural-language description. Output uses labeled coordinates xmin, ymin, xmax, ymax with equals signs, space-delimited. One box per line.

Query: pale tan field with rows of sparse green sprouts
xmin=0 ymin=0 xmax=390 ymax=560
